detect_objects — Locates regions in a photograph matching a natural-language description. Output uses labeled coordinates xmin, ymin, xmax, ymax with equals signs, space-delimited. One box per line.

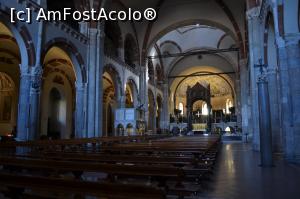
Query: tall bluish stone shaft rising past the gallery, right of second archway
xmin=87 ymin=28 xmax=99 ymax=137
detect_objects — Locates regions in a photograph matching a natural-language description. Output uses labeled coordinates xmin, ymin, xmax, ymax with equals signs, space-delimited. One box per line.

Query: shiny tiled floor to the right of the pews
xmin=200 ymin=143 xmax=300 ymax=199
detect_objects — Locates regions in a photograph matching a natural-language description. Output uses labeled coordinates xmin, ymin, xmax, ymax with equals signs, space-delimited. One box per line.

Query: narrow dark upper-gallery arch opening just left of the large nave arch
xmin=124 ymin=34 xmax=139 ymax=68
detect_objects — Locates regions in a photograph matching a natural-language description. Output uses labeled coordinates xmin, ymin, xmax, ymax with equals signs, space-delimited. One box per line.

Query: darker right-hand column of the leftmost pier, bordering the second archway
xmin=28 ymin=66 xmax=43 ymax=140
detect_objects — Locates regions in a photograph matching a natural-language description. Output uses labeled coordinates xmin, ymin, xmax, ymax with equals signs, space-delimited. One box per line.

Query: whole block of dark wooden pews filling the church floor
xmin=0 ymin=135 xmax=220 ymax=199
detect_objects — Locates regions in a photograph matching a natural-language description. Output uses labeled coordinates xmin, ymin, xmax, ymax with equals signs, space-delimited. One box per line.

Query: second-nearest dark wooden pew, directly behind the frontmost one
xmin=0 ymin=157 xmax=191 ymax=194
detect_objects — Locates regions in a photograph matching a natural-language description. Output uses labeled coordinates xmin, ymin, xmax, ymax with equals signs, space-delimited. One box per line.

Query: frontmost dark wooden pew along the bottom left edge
xmin=0 ymin=173 xmax=166 ymax=199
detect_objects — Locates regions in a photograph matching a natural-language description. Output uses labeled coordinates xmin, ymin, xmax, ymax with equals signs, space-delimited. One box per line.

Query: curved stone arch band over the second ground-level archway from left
xmin=41 ymin=37 xmax=87 ymax=83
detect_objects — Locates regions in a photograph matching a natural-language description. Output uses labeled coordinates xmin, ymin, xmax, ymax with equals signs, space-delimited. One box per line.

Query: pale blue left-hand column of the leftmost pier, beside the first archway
xmin=17 ymin=66 xmax=31 ymax=140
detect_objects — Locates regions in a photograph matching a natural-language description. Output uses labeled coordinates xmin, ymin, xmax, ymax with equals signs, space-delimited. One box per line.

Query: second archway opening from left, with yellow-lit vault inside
xmin=41 ymin=46 xmax=76 ymax=139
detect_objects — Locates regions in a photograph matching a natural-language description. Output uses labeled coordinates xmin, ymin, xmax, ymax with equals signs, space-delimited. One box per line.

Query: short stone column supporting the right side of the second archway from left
xmin=75 ymin=82 xmax=85 ymax=138
